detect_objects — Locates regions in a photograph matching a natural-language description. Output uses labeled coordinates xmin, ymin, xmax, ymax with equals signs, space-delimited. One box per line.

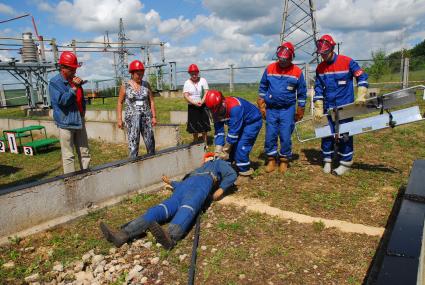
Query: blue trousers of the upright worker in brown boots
xmin=264 ymin=104 xmax=295 ymax=159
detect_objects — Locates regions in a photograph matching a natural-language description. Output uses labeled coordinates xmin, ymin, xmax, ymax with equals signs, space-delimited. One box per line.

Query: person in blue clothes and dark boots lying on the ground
xmin=100 ymin=153 xmax=237 ymax=250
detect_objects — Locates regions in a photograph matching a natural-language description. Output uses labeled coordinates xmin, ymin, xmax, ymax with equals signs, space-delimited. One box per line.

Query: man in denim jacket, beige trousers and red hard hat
xmin=49 ymin=51 xmax=90 ymax=174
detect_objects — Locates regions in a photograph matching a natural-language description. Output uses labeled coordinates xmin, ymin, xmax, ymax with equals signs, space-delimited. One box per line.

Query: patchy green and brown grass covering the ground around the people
xmin=0 ymin=86 xmax=425 ymax=285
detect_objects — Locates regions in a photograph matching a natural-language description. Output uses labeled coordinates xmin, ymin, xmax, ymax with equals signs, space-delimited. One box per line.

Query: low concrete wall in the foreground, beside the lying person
xmin=0 ymin=144 xmax=204 ymax=243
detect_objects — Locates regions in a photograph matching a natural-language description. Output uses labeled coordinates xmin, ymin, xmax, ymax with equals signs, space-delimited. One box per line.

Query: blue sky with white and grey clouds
xmin=0 ymin=0 xmax=425 ymax=83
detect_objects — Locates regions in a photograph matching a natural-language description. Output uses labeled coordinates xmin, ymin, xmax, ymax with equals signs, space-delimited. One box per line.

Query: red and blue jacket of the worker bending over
xmin=214 ymin=97 xmax=262 ymax=145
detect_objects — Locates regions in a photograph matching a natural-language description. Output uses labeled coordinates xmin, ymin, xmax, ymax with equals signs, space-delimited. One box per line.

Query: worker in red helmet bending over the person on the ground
xmin=205 ymin=90 xmax=263 ymax=185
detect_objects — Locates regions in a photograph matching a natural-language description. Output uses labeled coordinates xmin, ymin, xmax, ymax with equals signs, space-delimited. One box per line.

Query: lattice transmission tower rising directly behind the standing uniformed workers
xmin=280 ymin=0 xmax=318 ymax=62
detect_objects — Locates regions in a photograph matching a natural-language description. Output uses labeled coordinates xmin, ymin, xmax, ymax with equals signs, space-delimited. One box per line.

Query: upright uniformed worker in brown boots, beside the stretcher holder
xmin=257 ymin=42 xmax=307 ymax=173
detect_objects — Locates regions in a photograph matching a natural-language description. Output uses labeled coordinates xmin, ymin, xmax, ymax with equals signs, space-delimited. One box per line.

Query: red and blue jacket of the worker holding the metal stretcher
xmin=313 ymin=54 xmax=369 ymax=110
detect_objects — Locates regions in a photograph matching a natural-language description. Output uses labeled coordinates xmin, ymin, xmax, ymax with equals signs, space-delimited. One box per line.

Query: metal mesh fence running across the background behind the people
xmin=0 ymin=57 xmax=425 ymax=106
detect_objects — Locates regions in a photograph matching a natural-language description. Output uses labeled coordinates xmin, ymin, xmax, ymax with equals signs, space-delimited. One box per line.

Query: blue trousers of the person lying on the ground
xmin=121 ymin=174 xmax=214 ymax=241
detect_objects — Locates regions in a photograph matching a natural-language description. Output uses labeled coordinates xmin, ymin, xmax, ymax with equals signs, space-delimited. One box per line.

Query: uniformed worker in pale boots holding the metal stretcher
xmin=313 ymin=35 xmax=368 ymax=175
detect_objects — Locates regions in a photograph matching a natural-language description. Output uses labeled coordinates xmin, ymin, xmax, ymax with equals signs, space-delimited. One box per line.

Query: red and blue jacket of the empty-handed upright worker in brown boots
xmin=258 ymin=62 xmax=307 ymax=108
